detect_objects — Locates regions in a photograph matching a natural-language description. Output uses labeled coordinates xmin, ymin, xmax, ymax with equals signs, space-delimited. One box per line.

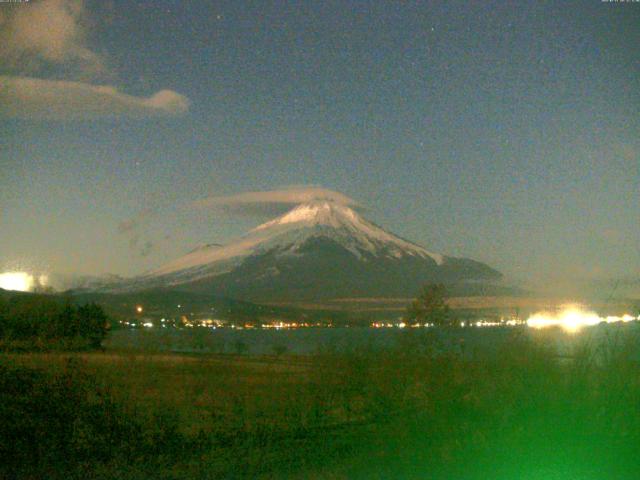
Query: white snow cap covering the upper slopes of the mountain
xmin=149 ymin=201 xmax=445 ymax=280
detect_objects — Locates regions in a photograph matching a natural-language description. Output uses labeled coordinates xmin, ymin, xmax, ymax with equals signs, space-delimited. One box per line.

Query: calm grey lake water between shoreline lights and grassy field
xmin=104 ymin=322 xmax=640 ymax=355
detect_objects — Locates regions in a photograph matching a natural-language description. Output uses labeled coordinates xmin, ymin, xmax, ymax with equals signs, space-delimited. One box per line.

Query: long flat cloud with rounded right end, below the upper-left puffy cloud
xmin=0 ymin=76 xmax=189 ymax=120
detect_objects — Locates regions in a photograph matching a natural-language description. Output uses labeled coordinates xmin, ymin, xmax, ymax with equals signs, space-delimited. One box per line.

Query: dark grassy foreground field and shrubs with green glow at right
xmin=0 ymin=329 xmax=640 ymax=479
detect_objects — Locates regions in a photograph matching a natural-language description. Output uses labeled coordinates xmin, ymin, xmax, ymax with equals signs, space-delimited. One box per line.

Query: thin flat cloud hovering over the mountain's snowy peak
xmin=191 ymin=187 xmax=359 ymax=214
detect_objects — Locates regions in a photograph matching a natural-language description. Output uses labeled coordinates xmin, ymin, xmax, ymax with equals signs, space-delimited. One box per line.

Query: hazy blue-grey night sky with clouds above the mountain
xmin=0 ymin=0 xmax=640 ymax=280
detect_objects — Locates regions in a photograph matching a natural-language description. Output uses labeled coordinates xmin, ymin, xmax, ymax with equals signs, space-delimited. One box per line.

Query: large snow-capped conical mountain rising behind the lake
xmin=114 ymin=200 xmax=502 ymax=302
